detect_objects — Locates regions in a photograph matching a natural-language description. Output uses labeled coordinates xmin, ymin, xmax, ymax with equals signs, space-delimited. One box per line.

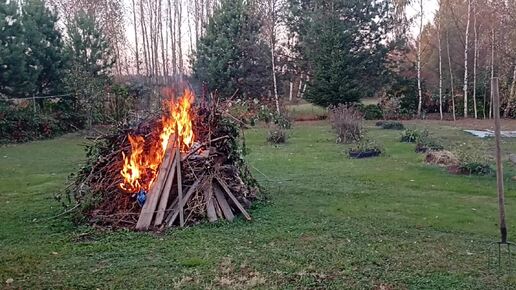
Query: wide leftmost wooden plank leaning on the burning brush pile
xmin=136 ymin=136 xmax=174 ymax=231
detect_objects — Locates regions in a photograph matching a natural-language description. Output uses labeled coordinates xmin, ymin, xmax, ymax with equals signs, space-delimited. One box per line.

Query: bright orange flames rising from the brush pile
xmin=120 ymin=90 xmax=194 ymax=192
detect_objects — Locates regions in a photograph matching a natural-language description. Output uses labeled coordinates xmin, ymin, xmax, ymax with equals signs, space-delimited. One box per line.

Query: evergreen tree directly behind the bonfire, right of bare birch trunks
xmin=192 ymin=0 xmax=272 ymax=97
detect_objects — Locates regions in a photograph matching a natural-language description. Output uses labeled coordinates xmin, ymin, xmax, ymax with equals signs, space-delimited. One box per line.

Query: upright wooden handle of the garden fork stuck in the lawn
xmin=491 ymin=78 xmax=507 ymax=244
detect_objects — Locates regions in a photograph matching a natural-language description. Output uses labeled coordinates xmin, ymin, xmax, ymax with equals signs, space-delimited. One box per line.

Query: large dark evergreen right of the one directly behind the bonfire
xmin=290 ymin=0 xmax=392 ymax=106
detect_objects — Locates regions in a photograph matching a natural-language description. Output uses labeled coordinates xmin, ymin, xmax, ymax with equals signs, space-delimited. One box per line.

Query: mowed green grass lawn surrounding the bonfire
xmin=0 ymin=122 xmax=516 ymax=289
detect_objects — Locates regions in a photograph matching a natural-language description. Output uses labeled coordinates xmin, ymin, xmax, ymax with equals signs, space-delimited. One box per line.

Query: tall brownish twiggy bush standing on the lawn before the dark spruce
xmin=329 ymin=105 xmax=364 ymax=144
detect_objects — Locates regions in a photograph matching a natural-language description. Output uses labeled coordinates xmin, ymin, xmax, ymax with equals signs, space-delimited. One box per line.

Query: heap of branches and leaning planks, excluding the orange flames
xmin=62 ymin=97 xmax=259 ymax=230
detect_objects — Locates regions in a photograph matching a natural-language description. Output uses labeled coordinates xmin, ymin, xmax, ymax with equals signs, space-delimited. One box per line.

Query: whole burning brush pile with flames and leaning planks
xmin=62 ymin=90 xmax=258 ymax=230
